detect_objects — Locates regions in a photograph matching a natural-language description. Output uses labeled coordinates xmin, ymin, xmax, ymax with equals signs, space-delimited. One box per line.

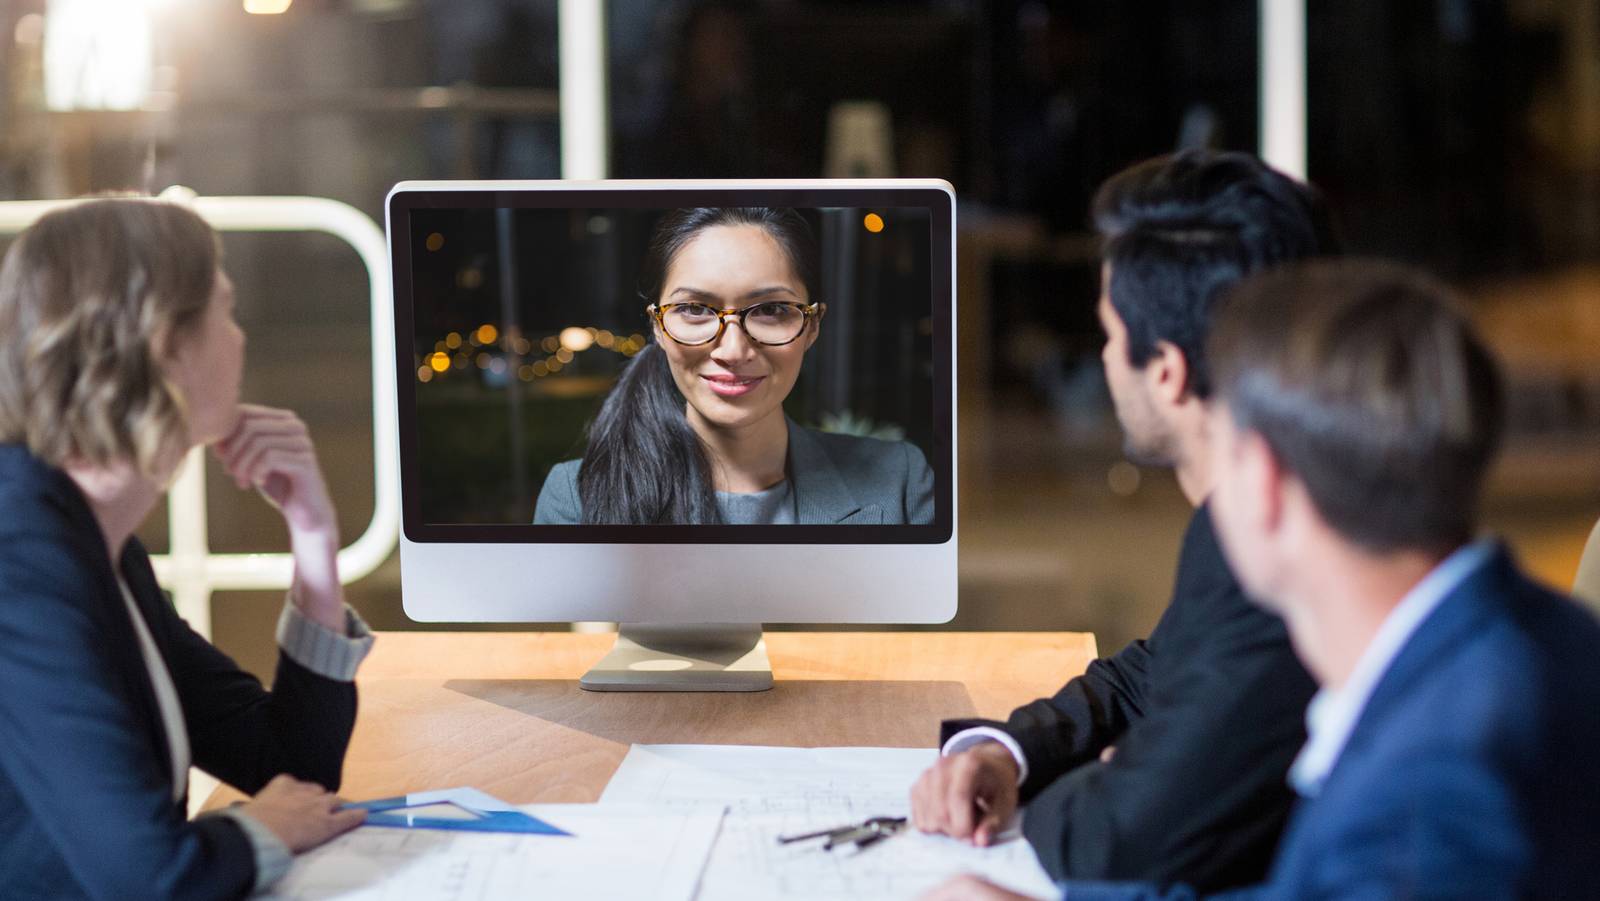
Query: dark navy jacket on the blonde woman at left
xmin=0 ymin=445 xmax=355 ymax=899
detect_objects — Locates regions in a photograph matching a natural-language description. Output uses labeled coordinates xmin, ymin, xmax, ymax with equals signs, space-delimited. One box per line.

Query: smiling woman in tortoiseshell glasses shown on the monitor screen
xmin=533 ymin=206 xmax=933 ymax=525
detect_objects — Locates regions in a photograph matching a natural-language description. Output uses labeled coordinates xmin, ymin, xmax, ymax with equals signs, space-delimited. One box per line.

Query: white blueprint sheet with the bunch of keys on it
xmin=600 ymin=744 xmax=1059 ymax=901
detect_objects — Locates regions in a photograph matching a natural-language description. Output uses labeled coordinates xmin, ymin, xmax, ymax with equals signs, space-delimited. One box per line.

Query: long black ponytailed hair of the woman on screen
xmin=578 ymin=206 xmax=816 ymax=525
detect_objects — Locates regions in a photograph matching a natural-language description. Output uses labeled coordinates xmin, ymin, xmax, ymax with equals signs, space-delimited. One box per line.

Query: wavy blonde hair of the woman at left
xmin=0 ymin=197 xmax=221 ymax=479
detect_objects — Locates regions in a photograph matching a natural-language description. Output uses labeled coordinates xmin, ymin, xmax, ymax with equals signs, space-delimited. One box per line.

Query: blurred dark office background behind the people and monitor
xmin=0 ymin=0 xmax=1600 ymax=672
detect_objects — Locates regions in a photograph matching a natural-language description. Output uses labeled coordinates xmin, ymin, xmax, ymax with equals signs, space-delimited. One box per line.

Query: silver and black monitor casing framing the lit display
xmin=384 ymin=179 xmax=957 ymax=623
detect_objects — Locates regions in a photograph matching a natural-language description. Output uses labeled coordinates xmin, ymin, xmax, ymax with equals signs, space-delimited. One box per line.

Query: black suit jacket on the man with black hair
xmin=944 ymin=507 xmax=1315 ymax=890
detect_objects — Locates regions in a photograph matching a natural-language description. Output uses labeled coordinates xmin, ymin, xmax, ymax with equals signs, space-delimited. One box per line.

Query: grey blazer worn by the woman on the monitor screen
xmin=533 ymin=419 xmax=933 ymax=525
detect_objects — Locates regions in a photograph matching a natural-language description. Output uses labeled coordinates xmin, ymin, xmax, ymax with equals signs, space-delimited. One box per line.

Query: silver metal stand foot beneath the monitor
xmin=578 ymin=623 xmax=773 ymax=691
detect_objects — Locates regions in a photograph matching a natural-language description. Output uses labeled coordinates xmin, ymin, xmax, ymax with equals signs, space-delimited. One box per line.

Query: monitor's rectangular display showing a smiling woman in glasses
xmin=406 ymin=201 xmax=949 ymax=528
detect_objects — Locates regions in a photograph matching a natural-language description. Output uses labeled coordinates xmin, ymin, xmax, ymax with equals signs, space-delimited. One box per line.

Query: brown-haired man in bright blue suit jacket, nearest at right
xmin=931 ymin=262 xmax=1600 ymax=901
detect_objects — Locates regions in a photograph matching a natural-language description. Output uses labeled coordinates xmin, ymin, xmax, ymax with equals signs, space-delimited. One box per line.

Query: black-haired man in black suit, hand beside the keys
xmin=912 ymin=152 xmax=1333 ymax=890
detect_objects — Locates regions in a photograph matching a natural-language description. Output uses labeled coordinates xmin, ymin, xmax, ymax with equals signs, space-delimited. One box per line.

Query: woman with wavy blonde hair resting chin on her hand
xmin=0 ymin=198 xmax=371 ymax=898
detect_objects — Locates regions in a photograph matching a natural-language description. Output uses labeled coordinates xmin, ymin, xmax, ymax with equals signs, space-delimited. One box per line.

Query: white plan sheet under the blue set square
xmin=267 ymin=803 xmax=722 ymax=901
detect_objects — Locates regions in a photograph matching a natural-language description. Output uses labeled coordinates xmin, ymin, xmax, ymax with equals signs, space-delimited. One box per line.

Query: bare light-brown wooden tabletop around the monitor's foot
xmin=206 ymin=632 xmax=1096 ymax=808
